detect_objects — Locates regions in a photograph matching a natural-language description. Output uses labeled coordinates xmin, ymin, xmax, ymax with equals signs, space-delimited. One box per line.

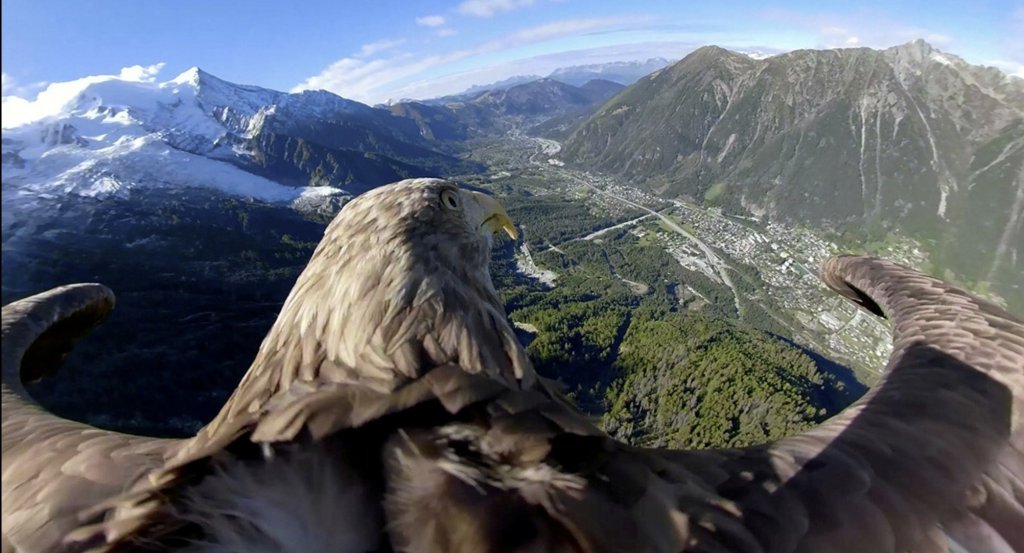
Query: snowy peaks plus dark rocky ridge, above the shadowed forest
xmin=3 ymin=68 xmax=473 ymax=204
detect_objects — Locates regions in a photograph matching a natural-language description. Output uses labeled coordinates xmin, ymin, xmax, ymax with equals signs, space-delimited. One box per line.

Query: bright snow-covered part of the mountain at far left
xmin=3 ymin=69 xmax=309 ymax=201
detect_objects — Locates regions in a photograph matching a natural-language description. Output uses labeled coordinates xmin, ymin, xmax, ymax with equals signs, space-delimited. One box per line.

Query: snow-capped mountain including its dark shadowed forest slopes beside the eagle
xmin=0 ymin=68 xmax=485 ymax=432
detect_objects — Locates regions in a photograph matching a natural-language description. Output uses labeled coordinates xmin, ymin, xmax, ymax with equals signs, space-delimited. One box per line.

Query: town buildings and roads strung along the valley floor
xmin=460 ymin=135 xmax=926 ymax=383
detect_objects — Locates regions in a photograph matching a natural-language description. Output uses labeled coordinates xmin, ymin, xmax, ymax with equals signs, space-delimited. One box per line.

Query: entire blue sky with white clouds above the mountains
xmin=0 ymin=0 xmax=1024 ymax=103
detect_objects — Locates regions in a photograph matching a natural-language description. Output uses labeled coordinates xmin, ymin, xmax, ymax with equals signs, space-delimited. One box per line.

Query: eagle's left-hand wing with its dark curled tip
xmin=2 ymin=284 xmax=178 ymax=551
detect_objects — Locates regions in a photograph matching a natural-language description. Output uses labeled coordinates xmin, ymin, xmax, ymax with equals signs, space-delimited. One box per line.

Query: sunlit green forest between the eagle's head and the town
xmin=494 ymin=190 xmax=865 ymax=446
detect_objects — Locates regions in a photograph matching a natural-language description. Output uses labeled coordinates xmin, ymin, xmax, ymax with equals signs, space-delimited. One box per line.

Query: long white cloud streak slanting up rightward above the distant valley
xmin=292 ymin=16 xmax=648 ymax=103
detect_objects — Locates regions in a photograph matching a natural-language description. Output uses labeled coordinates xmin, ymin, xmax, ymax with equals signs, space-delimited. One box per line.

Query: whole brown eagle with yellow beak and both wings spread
xmin=2 ymin=179 xmax=1024 ymax=553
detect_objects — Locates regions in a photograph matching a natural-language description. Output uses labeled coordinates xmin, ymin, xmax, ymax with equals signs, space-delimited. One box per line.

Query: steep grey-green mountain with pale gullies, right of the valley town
xmin=563 ymin=40 xmax=1024 ymax=309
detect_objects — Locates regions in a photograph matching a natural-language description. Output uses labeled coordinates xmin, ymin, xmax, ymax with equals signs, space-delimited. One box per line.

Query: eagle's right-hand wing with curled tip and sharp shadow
xmin=643 ymin=256 xmax=1024 ymax=553
